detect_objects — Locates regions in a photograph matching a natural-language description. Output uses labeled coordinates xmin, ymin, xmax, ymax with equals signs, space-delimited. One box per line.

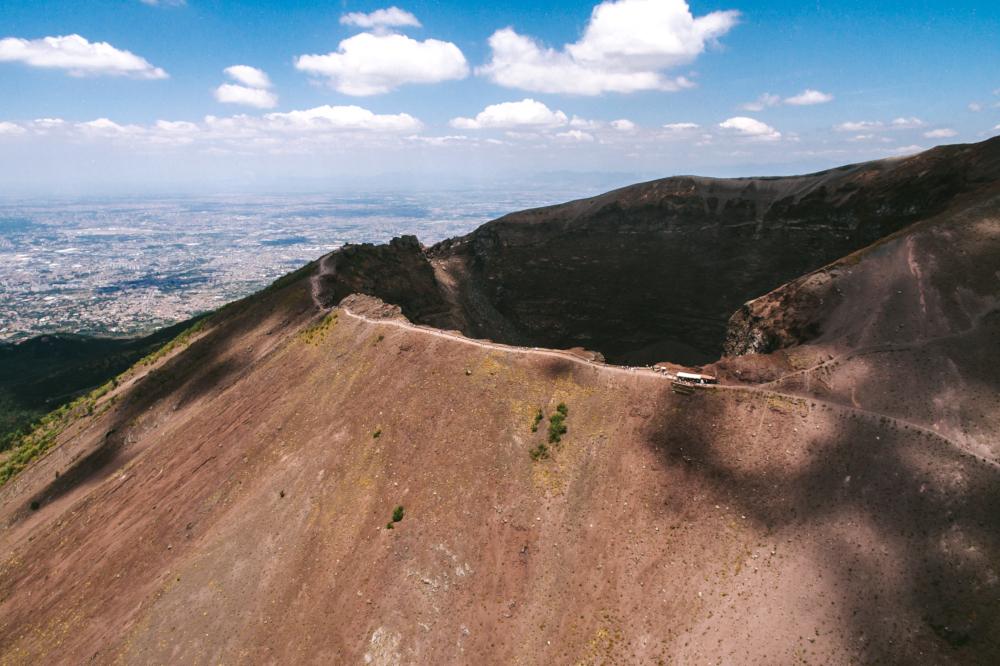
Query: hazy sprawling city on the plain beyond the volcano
xmin=0 ymin=189 xmax=590 ymax=342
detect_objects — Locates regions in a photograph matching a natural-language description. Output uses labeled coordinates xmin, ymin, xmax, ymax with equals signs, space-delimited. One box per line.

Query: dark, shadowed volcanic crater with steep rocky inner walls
xmin=317 ymin=139 xmax=996 ymax=365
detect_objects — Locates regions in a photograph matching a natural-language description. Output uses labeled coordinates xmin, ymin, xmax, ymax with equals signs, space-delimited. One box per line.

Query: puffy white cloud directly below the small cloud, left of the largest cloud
xmin=295 ymin=32 xmax=469 ymax=96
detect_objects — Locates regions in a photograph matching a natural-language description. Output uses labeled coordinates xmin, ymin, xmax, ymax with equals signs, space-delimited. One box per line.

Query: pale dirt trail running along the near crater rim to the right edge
xmin=338 ymin=303 xmax=1000 ymax=470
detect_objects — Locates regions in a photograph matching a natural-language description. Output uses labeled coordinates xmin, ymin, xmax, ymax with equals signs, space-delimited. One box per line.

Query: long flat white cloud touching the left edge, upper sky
xmin=0 ymin=35 xmax=167 ymax=79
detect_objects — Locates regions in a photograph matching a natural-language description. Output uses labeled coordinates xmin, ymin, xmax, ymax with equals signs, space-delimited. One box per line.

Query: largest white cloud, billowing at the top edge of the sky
xmin=476 ymin=0 xmax=739 ymax=95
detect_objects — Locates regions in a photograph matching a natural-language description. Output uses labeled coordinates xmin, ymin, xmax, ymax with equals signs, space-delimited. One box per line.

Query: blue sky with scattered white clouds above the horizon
xmin=0 ymin=0 xmax=1000 ymax=196
